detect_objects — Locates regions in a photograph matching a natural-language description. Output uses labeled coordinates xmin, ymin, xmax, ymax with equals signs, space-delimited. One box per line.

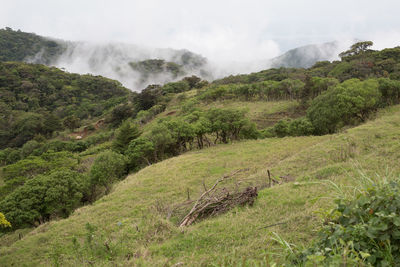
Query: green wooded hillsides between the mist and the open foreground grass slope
xmin=0 ymin=37 xmax=400 ymax=266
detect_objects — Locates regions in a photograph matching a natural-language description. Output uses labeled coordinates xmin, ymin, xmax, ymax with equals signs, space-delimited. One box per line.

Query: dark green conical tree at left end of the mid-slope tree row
xmin=112 ymin=121 xmax=141 ymax=154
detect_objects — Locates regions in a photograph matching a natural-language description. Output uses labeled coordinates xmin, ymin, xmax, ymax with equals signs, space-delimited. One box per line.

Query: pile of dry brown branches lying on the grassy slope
xmin=180 ymin=170 xmax=258 ymax=227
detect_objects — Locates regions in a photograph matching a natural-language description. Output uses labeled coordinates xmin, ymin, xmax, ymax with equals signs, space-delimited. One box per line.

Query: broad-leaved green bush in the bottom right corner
xmin=297 ymin=178 xmax=400 ymax=266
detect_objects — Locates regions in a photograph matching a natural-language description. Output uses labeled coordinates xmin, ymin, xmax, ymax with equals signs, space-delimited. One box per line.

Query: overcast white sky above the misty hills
xmin=0 ymin=0 xmax=400 ymax=61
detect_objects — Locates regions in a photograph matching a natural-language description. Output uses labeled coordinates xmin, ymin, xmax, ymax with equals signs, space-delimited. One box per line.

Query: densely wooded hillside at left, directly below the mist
xmin=0 ymin=62 xmax=131 ymax=148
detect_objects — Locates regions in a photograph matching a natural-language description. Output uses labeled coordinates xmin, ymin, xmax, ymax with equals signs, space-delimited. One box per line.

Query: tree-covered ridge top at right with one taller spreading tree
xmin=213 ymin=41 xmax=400 ymax=85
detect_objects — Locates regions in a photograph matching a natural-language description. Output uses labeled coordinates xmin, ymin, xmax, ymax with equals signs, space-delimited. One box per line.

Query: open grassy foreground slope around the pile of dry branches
xmin=0 ymin=106 xmax=400 ymax=266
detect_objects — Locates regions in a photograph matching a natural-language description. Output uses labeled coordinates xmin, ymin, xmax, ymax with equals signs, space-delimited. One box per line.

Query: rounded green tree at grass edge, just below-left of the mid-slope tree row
xmin=90 ymin=151 xmax=127 ymax=193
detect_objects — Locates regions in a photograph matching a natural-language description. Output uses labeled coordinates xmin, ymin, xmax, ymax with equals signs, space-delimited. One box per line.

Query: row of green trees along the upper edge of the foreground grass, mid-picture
xmin=113 ymin=109 xmax=260 ymax=170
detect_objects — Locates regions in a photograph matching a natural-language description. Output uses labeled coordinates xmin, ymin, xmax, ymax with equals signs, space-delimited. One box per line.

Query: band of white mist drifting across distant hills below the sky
xmin=25 ymin=35 xmax=351 ymax=91
